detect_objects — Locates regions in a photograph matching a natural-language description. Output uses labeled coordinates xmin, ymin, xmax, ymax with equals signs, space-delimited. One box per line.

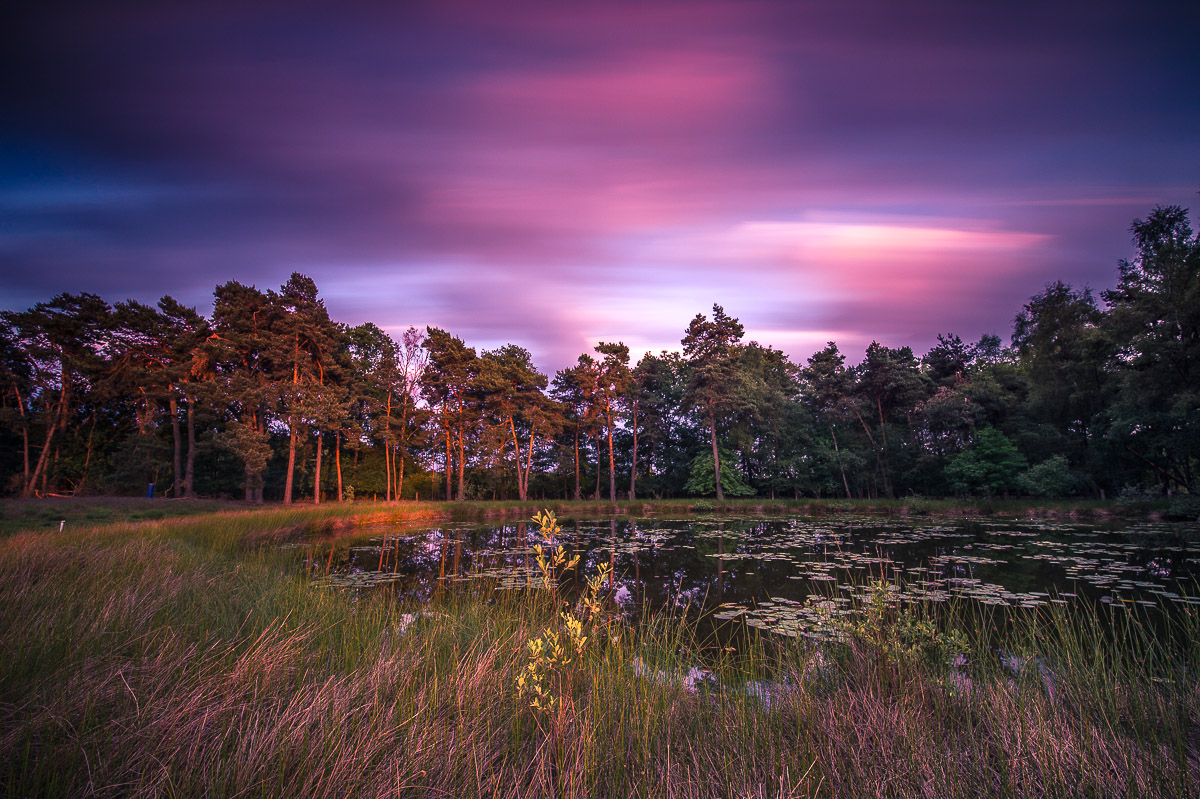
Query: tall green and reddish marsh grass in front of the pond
xmin=0 ymin=507 xmax=1200 ymax=797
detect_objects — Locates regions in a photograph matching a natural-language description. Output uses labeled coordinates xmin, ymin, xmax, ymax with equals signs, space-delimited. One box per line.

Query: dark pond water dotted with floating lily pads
xmin=307 ymin=516 xmax=1200 ymax=639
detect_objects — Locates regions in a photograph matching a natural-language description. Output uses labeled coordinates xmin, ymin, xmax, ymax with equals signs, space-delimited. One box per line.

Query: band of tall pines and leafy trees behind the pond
xmin=0 ymin=206 xmax=1200 ymax=503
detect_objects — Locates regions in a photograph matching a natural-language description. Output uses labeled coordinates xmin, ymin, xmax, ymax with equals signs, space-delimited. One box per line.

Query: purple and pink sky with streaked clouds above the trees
xmin=0 ymin=0 xmax=1200 ymax=373
